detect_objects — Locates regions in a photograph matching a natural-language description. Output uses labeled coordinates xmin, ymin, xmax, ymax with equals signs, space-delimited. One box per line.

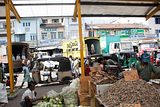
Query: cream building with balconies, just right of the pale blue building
xmin=39 ymin=18 xmax=65 ymax=47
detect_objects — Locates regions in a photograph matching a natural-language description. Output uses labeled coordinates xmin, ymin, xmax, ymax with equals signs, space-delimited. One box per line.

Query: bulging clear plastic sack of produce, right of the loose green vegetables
xmin=61 ymin=87 xmax=78 ymax=107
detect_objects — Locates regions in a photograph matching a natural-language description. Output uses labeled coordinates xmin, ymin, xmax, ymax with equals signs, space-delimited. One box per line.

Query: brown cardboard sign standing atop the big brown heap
xmin=123 ymin=70 xmax=139 ymax=81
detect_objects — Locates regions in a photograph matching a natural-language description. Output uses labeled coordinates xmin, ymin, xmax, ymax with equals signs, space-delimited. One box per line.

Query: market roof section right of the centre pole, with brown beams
xmin=74 ymin=0 xmax=160 ymax=20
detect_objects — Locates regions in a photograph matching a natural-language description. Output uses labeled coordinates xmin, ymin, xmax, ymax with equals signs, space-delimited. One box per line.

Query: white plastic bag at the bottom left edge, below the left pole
xmin=0 ymin=83 xmax=8 ymax=103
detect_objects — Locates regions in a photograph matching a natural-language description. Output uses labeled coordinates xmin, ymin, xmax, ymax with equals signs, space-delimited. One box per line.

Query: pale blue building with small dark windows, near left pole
xmin=14 ymin=18 xmax=41 ymax=48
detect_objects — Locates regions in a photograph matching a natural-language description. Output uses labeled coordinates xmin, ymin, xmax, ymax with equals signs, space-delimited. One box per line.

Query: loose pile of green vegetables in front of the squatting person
xmin=33 ymin=96 xmax=63 ymax=107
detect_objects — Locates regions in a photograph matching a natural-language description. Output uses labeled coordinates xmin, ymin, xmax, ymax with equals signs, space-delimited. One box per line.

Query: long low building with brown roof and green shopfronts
xmin=85 ymin=23 xmax=149 ymax=37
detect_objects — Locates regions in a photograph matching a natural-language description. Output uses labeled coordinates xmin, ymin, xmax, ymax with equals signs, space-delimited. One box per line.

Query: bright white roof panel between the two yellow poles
xmin=13 ymin=0 xmax=75 ymax=18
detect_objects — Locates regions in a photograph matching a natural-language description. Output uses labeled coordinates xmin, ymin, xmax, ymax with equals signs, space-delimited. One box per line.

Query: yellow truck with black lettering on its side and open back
xmin=62 ymin=37 xmax=101 ymax=58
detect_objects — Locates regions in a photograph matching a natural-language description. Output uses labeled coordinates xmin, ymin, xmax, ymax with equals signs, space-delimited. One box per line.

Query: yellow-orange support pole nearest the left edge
xmin=5 ymin=0 xmax=14 ymax=93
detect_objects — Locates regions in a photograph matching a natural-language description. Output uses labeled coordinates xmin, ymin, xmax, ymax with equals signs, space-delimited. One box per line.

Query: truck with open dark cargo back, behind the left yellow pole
xmin=0 ymin=42 xmax=29 ymax=72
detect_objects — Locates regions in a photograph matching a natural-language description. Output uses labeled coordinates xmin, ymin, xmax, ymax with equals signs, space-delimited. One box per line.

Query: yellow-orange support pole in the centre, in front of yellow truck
xmin=76 ymin=0 xmax=85 ymax=76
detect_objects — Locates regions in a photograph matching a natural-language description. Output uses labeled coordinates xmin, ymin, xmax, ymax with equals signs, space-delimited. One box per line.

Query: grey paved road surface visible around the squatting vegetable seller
xmin=5 ymin=85 xmax=67 ymax=107
